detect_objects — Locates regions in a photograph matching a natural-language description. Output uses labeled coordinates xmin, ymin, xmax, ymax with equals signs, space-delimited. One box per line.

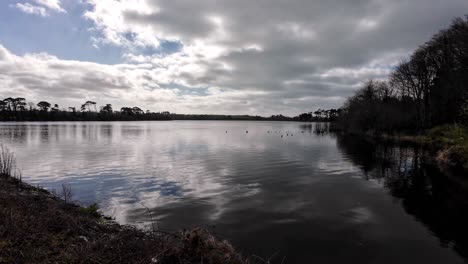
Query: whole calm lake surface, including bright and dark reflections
xmin=0 ymin=121 xmax=468 ymax=263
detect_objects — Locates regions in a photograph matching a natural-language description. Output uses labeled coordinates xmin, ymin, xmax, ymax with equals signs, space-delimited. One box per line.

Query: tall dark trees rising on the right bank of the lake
xmin=337 ymin=16 xmax=468 ymax=132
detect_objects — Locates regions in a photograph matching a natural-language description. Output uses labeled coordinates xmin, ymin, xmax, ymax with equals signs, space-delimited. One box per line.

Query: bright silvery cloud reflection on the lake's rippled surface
xmin=1 ymin=122 xmax=358 ymax=223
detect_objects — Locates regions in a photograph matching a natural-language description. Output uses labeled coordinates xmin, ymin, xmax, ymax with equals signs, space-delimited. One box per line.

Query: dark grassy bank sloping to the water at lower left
xmin=0 ymin=167 xmax=251 ymax=263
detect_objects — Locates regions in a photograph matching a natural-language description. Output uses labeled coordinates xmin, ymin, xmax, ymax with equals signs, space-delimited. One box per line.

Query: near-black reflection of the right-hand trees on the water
xmin=337 ymin=136 xmax=468 ymax=258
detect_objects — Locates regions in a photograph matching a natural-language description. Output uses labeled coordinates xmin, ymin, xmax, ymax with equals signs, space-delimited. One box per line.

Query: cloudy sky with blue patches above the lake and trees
xmin=0 ymin=0 xmax=468 ymax=116
